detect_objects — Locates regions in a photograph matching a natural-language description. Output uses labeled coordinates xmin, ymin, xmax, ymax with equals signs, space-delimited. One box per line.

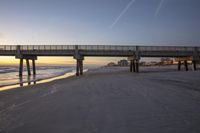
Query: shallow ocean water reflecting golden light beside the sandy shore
xmin=0 ymin=66 xmax=75 ymax=88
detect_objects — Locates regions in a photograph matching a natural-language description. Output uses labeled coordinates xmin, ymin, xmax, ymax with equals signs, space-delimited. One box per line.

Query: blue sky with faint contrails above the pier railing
xmin=0 ymin=0 xmax=200 ymax=46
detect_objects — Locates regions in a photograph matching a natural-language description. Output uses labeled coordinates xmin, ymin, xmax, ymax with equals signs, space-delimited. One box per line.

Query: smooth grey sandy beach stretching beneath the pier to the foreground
xmin=0 ymin=67 xmax=200 ymax=133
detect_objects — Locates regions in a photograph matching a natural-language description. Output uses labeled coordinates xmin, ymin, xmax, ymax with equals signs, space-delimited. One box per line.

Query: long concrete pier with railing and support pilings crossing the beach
xmin=0 ymin=45 xmax=200 ymax=76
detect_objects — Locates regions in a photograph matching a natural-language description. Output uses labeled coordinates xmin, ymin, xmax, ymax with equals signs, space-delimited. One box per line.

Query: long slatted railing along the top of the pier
xmin=0 ymin=45 xmax=200 ymax=51
